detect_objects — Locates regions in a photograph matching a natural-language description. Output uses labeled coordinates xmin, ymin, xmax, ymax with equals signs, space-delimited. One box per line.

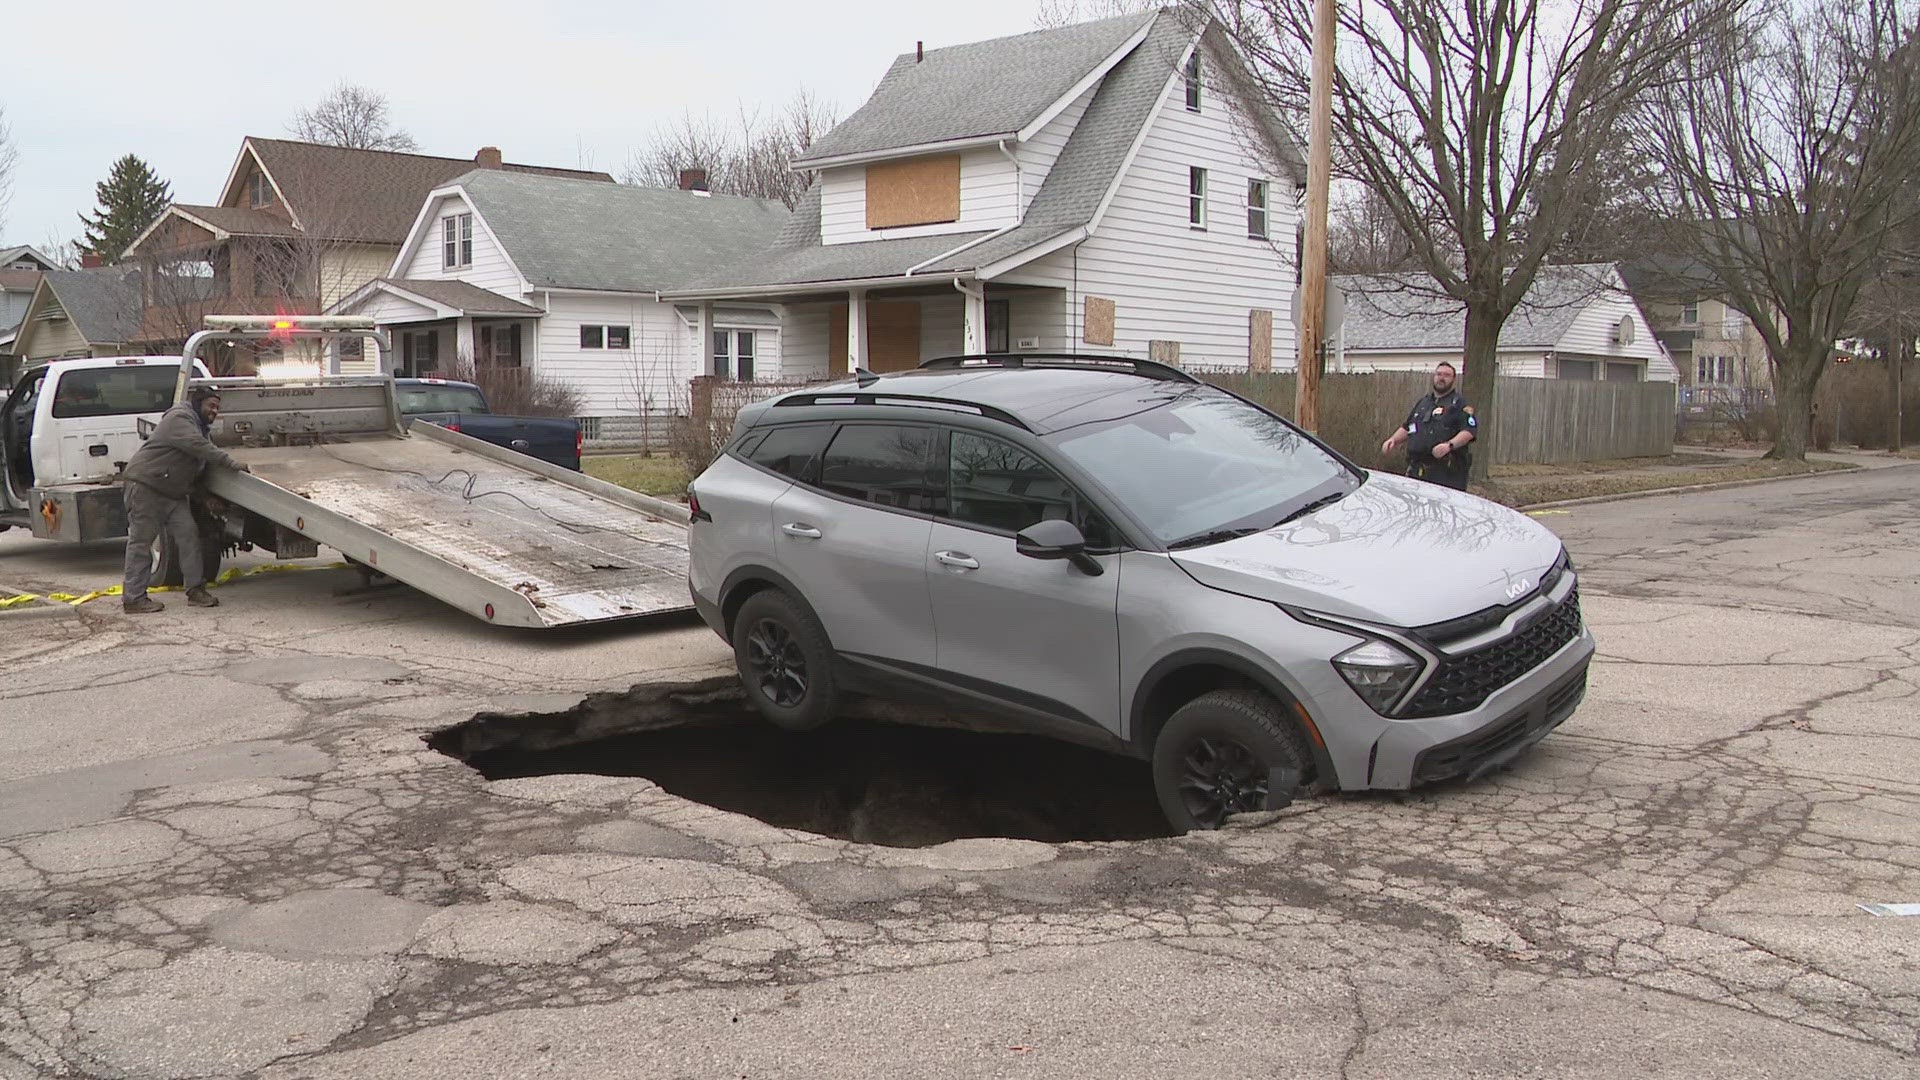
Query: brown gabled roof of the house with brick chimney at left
xmin=221 ymin=136 xmax=612 ymax=244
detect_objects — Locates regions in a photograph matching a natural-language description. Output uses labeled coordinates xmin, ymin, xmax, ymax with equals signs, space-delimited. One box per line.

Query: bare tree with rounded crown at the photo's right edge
xmin=1644 ymin=0 xmax=1920 ymax=459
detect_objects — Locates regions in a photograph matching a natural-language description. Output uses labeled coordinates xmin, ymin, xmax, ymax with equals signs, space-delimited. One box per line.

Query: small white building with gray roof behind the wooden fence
xmin=1327 ymin=263 xmax=1678 ymax=382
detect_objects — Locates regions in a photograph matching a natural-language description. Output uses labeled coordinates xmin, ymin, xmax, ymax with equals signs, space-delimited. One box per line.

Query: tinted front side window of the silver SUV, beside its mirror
xmin=947 ymin=430 xmax=1116 ymax=548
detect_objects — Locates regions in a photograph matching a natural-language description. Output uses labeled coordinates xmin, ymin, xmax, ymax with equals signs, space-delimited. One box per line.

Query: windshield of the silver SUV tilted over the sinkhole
xmin=1050 ymin=388 xmax=1359 ymax=546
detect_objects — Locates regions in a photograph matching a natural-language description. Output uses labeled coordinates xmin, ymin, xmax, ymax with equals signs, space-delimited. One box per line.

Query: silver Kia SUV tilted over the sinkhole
xmin=689 ymin=356 xmax=1594 ymax=830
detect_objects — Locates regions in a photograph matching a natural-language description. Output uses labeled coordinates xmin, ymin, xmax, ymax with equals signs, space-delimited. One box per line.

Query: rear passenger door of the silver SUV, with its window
xmin=774 ymin=423 xmax=935 ymax=669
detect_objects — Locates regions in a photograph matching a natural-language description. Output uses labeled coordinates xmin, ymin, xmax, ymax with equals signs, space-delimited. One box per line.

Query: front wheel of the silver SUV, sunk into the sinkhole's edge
xmin=1154 ymin=690 xmax=1313 ymax=832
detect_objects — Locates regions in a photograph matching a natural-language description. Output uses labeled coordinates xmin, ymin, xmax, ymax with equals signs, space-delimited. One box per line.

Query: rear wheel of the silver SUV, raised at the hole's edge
xmin=733 ymin=590 xmax=837 ymax=732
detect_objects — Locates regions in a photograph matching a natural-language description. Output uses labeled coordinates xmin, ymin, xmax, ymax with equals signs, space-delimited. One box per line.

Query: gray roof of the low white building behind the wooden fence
xmin=1332 ymin=263 xmax=1615 ymax=352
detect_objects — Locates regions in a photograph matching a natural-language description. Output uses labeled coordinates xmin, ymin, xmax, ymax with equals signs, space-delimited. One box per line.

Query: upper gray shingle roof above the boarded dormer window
xmin=795 ymin=12 xmax=1154 ymax=165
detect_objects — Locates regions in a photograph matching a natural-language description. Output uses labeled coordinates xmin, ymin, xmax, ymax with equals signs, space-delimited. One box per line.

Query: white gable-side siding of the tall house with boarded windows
xmin=1002 ymin=68 xmax=1298 ymax=369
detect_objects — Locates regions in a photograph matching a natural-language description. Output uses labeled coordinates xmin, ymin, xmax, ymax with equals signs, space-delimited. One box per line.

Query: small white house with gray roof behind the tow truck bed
xmin=332 ymin=169 xmax=787 ymax=417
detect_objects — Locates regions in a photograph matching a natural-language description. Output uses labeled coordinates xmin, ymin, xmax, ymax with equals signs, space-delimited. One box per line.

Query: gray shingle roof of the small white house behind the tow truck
xmin=457 ymin=169 xmax=789 ymax=292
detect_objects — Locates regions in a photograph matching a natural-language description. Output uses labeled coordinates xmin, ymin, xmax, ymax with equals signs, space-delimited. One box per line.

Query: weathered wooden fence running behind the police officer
xmin=1194 ymin=371 xmax=1674 ymax=469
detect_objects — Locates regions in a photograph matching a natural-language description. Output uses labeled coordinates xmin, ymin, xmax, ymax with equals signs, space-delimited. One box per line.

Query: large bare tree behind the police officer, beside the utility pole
xmin=1221 ymin=0 xmax=1745 ymax=477
